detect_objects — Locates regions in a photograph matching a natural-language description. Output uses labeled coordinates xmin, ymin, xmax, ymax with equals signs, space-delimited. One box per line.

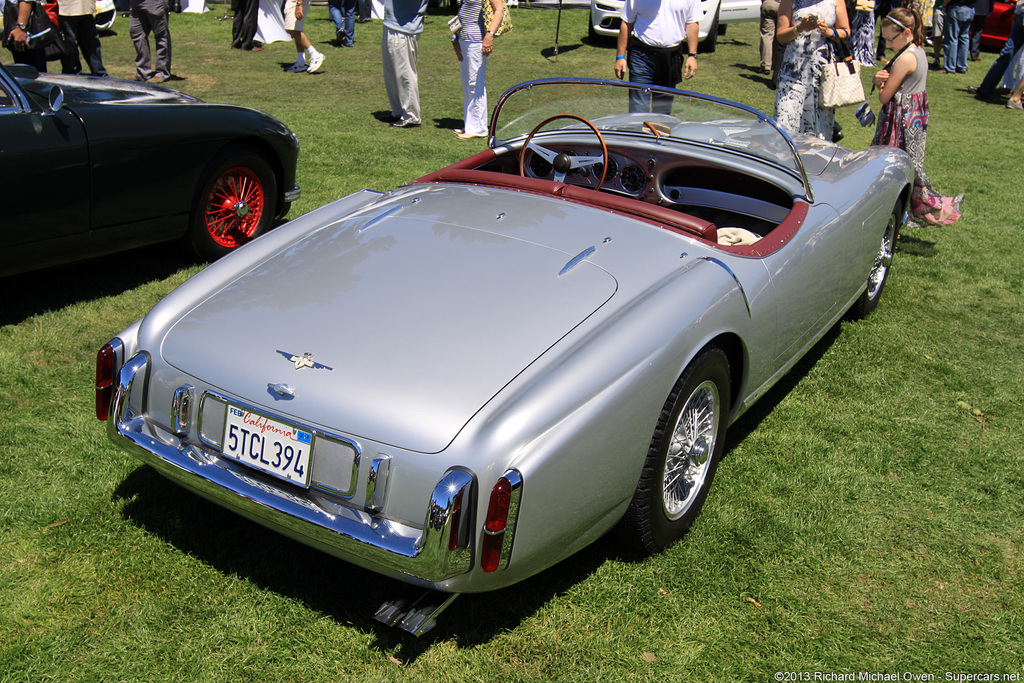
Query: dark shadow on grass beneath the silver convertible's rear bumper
xmin=113 ymin=466 xmax=610 ymax=651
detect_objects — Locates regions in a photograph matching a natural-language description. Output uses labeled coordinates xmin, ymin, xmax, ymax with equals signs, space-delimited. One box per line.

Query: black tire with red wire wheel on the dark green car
xmin=188 ymin=147 xmax=278 ymax=261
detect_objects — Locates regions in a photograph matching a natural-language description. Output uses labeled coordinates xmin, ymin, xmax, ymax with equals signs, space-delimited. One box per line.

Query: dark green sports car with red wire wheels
xmin=0 ymin=66 xmax=300 ymax=276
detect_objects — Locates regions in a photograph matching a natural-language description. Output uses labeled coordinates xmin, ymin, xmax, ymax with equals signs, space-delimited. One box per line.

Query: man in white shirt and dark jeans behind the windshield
xmin=615 ymin=0 xmax=700 ymax=114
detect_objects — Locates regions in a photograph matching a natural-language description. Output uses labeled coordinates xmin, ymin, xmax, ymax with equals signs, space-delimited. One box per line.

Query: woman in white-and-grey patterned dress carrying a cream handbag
xmin=775 ymin=0 xmax=850 ymax=140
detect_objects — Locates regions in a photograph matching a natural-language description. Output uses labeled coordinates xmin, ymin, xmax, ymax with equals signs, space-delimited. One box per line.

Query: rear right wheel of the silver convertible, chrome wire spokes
xmin=620 ymin=347 xmax=731 ymax=555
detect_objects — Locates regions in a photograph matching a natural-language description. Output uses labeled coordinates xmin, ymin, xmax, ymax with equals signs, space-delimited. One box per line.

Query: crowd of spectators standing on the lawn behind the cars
xmin=8 ymin=0 xmax=1024 ymax=224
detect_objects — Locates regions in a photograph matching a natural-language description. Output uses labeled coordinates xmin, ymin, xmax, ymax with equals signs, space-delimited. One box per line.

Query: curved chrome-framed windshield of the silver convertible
xmin=490 ymin=79 xmax=809 ymax=190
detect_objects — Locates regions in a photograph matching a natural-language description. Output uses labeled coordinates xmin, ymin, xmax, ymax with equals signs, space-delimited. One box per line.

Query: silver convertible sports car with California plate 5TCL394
xmin=96 ymin=79 xmax=913 ymax=633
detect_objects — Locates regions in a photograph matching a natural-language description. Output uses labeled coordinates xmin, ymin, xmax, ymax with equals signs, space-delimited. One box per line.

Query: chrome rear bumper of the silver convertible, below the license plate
xmin=108 ymin=353 xmax=475 ymax=588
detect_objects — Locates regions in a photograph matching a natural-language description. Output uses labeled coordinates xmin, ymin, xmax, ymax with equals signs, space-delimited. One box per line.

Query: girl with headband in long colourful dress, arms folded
xmin=871 ymin=7 xmax=964 ymax=225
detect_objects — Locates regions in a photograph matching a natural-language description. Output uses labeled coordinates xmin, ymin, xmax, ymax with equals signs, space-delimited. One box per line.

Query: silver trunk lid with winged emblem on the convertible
xmin=161 ymin=198 xmax=616 ymax=453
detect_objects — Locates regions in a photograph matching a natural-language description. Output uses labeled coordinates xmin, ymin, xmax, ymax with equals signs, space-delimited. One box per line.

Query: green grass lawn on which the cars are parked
xmin=0 ymin=5 xmax=1024 ymax=683
